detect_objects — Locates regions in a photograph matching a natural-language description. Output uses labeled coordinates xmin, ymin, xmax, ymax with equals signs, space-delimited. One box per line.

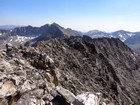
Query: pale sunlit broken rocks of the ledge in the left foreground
xmin=0 ymin=44 xmax=109 ymax=105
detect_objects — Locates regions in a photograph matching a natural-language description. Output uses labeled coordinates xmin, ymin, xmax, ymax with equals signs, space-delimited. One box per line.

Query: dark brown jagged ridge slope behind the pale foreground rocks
xmin=37 ymin=36 xmax=140 ymax=105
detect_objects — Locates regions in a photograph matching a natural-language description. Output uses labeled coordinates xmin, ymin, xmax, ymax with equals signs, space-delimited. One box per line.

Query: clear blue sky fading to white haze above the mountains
xmin=0 ymin=0 xmax=140 ymax=32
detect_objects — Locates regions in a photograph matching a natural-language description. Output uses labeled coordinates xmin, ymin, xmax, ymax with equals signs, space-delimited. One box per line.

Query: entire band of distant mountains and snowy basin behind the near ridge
xmin=0 ymin=23 xmax=140 ymax=53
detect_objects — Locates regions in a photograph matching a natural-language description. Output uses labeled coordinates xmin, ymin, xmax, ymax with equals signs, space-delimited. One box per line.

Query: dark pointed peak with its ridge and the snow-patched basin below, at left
xmin=0 ymin=23 xmax=82 ymax=50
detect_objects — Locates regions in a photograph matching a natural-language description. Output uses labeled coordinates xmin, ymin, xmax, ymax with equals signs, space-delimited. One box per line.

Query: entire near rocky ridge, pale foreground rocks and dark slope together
xmin=0 ymin=36 xmax=140 ymax=105
